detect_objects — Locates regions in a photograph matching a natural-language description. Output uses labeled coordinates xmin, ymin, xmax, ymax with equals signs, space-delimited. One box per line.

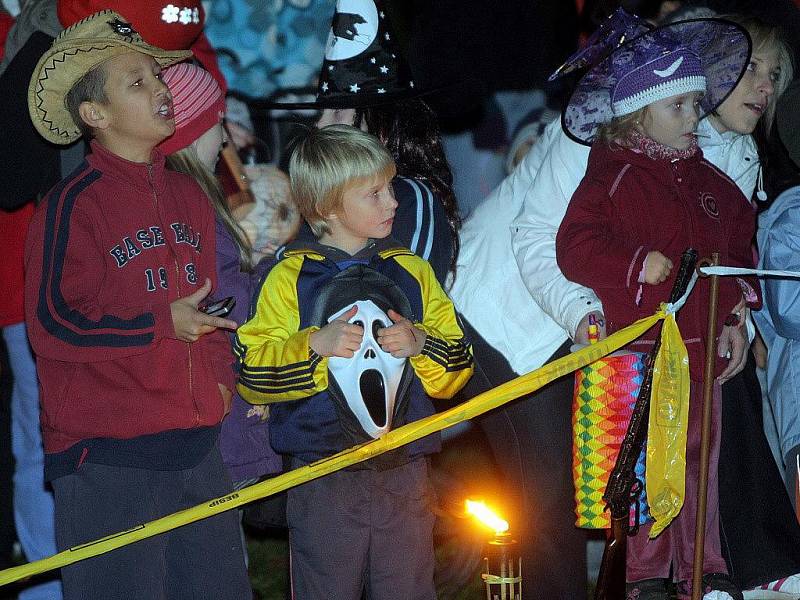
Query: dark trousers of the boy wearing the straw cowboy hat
xmin=53 ymin=447 xmax=252 ymax=600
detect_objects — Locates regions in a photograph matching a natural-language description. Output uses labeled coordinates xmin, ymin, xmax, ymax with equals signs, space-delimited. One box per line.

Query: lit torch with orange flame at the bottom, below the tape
xmin=467 ymin=500 xmax=522 ymax=600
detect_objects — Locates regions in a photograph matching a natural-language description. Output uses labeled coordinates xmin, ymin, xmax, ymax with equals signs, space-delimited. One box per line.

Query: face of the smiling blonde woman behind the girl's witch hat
xmin=709 ymin=48 xmax=781 ymax=135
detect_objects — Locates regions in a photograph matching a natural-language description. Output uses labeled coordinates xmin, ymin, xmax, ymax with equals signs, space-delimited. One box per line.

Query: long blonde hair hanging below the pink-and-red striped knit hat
xmin=162 ymin=146 xmax=253 ymax=272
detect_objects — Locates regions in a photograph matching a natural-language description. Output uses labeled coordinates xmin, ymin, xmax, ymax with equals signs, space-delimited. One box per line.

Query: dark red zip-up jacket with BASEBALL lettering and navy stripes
xmin=25 ymin=142 xmax=234 ymax=453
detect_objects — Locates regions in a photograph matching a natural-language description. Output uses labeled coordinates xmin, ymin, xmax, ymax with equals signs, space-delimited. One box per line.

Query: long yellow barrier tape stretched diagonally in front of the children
xmin=0 ymin=310 xmax=664 ymax=586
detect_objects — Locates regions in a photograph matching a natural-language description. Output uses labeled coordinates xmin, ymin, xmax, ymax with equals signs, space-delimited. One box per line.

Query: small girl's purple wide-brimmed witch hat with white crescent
xmin=561 ymin=18 xmax=751 ymax=145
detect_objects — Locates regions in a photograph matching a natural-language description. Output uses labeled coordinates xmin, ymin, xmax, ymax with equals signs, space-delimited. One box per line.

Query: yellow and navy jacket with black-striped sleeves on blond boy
xmin=235 ymin=239 xmax=473 ymax=461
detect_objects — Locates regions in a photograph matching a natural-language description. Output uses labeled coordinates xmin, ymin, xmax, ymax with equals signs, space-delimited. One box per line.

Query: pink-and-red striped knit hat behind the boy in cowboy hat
xmin=158 ymin=63 xmax=225 ymax=155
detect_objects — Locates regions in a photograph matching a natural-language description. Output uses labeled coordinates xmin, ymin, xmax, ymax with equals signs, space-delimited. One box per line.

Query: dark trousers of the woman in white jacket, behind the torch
xmin=465 ymin=324 xmax=587 ymax=600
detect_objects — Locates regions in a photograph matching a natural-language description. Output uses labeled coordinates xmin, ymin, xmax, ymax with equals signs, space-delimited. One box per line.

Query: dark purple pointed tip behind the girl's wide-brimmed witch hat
xmin=548 ymin=8 xmax=652 ymax=81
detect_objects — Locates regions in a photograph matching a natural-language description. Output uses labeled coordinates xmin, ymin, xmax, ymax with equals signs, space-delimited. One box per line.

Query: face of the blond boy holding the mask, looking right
xmin=323 ymin=177 xmax=397 ymax=254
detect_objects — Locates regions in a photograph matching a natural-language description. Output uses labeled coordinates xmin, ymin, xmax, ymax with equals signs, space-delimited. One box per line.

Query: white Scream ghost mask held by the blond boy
xmin=328 ymin=300 xmax=406 ymax=439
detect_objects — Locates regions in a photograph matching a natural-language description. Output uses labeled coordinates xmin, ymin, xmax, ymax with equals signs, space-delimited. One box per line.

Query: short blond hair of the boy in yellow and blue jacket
xmin=289 ymin=125 xmax=397 ymax=237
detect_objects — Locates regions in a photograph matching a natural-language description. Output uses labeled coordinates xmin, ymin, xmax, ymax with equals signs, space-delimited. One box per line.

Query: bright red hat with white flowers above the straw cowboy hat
xmin=56 ymin=0 xmax=205 ymax=50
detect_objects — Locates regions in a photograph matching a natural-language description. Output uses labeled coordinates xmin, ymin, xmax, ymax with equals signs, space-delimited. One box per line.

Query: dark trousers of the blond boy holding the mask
xmin=286 ymin=458 xmax=436 ymax=600
